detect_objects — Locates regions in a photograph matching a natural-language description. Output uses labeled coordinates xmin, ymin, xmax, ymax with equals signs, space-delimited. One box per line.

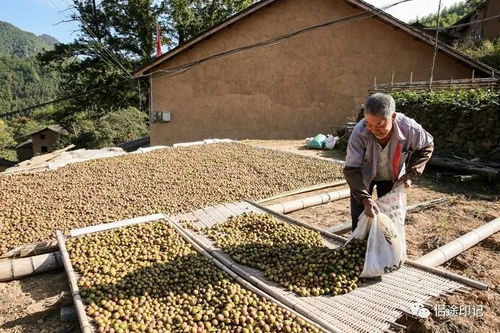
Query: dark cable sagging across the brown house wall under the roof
xmin=138 ymin=0 xmax=414 ymax=78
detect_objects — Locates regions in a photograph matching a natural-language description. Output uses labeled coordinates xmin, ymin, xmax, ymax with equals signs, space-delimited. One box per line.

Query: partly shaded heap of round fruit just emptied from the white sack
xmin=203 ymin=213 xmax=366 ymax=296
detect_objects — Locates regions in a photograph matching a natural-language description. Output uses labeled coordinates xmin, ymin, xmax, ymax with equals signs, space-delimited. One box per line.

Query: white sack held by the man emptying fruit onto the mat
xmin=347 ymin=185 xmax=406 ymax=278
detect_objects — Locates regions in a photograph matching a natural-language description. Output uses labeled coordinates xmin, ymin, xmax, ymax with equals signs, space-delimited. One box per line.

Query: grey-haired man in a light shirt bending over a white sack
xmin=344 ymin=93 xmax=434 ymax=231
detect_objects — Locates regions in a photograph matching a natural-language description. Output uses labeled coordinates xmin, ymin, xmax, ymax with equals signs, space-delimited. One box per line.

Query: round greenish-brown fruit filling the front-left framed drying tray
xmin=66 ymin=221 xmax=319 ymax=332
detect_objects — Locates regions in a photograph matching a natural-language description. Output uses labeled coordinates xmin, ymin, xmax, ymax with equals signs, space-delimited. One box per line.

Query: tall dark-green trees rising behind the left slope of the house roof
xmin=39 ymin=0 xmax=252 ymax=146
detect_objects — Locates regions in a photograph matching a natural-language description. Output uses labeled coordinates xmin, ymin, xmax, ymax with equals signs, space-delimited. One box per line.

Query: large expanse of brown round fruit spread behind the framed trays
xmin=0 ymin=143 xmax=342 ymax=254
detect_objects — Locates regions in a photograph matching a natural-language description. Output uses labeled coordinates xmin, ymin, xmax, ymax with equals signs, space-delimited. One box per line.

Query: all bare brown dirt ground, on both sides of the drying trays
xmin=0 ymin=140 xmax=500 ymax=333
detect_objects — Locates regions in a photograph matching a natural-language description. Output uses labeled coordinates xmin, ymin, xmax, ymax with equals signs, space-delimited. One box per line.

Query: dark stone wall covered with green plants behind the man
xmin=393 ymin=89 xmax=500 ymax=161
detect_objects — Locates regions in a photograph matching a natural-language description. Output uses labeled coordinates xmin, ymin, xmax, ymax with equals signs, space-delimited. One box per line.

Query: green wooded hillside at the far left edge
xmin=0 ymin=21 xmax=60 ymax=160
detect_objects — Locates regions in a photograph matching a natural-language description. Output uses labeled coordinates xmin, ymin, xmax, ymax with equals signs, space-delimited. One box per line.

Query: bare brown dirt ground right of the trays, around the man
xmin=249 ymin=140 xmax=500 ymax=333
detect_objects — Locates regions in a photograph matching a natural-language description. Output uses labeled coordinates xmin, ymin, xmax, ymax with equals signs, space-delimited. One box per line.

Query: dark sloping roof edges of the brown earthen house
xmin=133 ymin=0 xmax=500 ymax=77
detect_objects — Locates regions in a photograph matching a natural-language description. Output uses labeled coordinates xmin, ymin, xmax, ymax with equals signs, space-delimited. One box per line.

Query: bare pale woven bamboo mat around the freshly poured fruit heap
xmin=171 ymin=202 xmax=466 ymax=333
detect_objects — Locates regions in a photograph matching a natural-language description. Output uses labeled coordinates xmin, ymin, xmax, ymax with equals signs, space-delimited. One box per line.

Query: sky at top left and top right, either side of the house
xmin=0 ymin=0 xmax=463 ymax=43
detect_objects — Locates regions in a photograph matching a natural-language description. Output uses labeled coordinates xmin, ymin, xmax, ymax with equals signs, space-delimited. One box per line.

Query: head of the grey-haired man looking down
xmin=365 ymin=93 xmax=396 ymax=140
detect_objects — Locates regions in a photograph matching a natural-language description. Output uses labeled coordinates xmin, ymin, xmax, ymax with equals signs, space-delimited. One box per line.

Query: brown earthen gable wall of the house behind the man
xmin=134 ymin=0 xmax=491 ymax=145
